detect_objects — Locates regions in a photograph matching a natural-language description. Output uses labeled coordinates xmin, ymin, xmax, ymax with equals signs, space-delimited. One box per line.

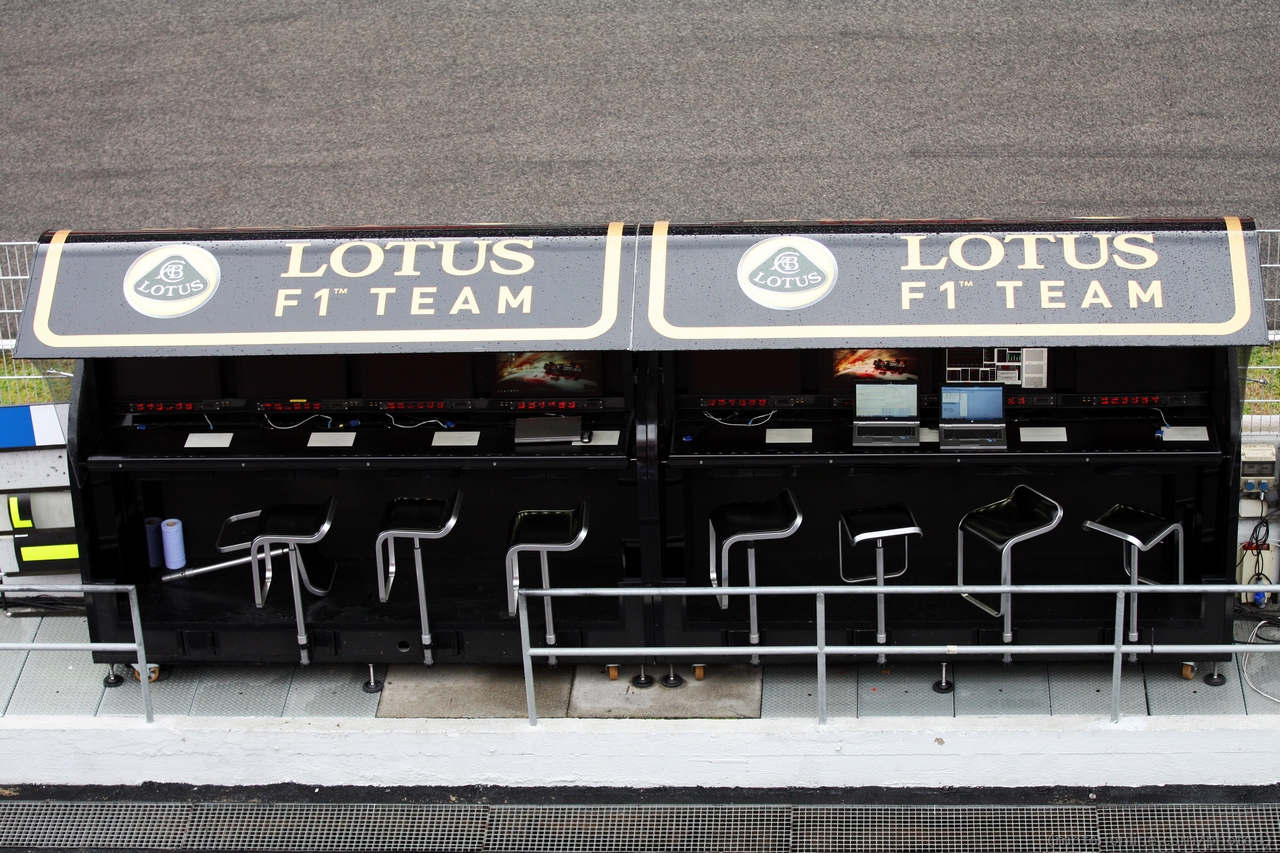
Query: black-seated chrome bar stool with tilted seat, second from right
xmin=956 ymin=485 xmax=1062 ymax=661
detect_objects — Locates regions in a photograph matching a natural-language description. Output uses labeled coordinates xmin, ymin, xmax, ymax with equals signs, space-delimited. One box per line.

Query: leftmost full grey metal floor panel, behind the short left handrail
xmin=5 ymin=616 xmax=104 ymax=717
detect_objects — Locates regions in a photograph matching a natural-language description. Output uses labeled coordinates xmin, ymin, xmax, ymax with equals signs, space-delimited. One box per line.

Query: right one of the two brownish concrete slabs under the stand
xmin=568 ymin=665 xmax=763 ymax=720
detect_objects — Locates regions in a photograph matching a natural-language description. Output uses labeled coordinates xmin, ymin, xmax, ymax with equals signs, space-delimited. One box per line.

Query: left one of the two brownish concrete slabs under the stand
xmin=378 ymin=663 xmax=573 ymax=719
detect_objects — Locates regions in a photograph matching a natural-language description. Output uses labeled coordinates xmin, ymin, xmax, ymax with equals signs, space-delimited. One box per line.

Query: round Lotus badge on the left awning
xmin=124 ymin=245 xmax=221 ymax=319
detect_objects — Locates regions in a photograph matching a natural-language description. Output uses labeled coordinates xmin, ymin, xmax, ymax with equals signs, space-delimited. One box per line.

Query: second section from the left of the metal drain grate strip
xmin=183 ymin=803 xmax=489 ymax=850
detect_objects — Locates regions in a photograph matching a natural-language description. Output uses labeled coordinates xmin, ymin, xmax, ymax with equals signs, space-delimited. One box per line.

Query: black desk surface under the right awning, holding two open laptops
xmin=668 ymin=412 xmax=1222 ymax=466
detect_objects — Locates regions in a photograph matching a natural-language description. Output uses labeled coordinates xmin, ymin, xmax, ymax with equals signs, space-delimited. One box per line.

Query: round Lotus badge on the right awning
xmin=737 ymin=237 xmax=837 ymax=310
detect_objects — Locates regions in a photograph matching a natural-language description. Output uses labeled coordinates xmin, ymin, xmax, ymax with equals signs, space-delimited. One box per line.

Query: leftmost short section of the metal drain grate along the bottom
xmin=0 ymin=803 xmax=193 ymax=850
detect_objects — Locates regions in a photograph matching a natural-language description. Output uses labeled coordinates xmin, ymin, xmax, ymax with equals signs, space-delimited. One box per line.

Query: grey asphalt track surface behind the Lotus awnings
xmin=0 ymin=0 xmax=1280 ymax=240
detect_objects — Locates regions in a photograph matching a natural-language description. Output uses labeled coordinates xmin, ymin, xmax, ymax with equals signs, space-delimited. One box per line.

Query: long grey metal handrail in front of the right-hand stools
xmin=517 ymin=584 xmax=1280 ymax=726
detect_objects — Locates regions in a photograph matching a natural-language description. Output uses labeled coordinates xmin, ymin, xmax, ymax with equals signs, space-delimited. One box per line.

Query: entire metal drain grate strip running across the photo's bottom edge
xmin=0 ymin=802 xmax=1280 ymax=853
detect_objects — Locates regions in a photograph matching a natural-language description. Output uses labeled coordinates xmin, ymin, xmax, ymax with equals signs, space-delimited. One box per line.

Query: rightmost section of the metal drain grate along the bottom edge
xmin=1098 ymin=804 xmax=1280 ymax=853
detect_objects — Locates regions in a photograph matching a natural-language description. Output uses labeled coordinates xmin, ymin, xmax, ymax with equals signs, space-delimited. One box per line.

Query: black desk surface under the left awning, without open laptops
xmin=84 ymin=412 xmax=635 ymax=470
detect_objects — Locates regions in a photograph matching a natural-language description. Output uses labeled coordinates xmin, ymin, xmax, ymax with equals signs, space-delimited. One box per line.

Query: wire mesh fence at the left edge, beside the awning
xmin=0 ymin=243 xmax=74 ymax=406
